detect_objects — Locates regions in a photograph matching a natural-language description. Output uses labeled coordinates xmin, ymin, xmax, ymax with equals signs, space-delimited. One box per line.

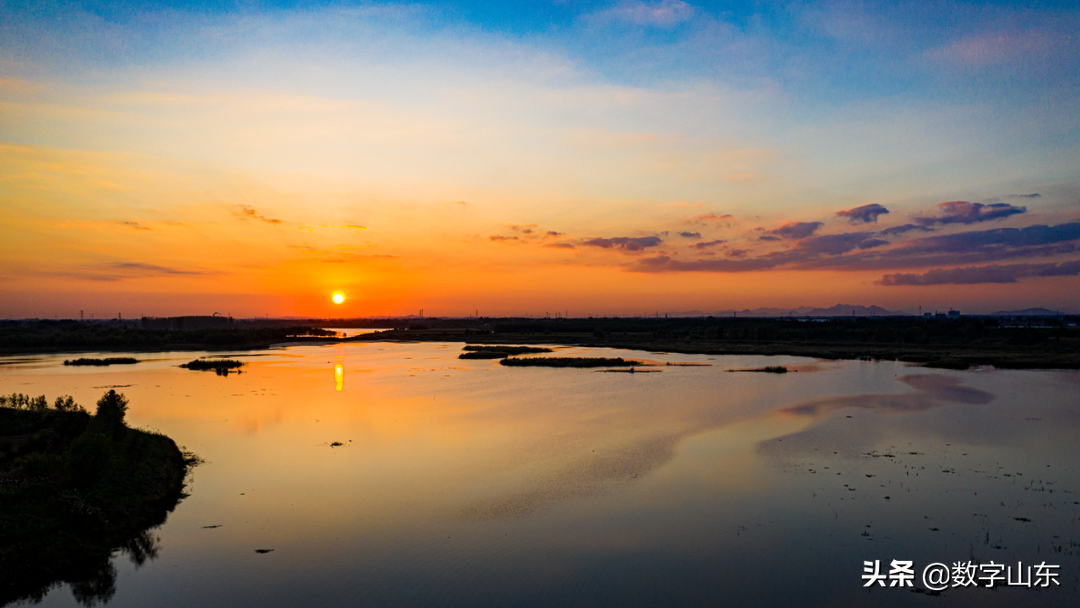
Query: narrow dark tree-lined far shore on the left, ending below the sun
xmin=0 ymin=321 xmax=335 ymax=350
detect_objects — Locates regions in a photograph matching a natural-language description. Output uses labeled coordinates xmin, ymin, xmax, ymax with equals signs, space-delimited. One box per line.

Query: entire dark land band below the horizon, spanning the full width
xmin=0 ymin=316 xmax=1080 ymax=369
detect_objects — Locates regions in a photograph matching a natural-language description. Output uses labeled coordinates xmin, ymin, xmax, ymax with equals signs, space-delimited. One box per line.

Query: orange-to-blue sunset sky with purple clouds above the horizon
xmin=0 ymin=0 xmax=1080 ymax=319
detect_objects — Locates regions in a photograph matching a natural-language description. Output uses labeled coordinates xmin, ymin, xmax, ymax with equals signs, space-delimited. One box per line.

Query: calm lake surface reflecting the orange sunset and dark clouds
xmin=0 ymin=343 xmax=1080 ymax=607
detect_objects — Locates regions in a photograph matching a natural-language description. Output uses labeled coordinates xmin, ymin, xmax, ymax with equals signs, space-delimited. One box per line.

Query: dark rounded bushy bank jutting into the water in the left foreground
xmin=0 ymin=390 xmax=195 ymax=606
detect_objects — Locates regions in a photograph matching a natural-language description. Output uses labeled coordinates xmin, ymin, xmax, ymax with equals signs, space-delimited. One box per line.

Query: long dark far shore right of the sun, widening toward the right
xmin=335 ymin=315 xmax=1080 ymax=369
